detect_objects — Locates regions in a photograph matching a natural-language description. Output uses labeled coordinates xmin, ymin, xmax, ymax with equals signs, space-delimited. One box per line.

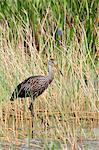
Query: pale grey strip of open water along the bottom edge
xmin=0 ymin=139 xmax=99 ymax=150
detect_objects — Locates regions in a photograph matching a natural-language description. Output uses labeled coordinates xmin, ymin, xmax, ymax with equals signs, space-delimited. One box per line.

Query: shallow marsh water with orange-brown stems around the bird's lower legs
xmin=0 ymin=101 xmax=99 ymax=150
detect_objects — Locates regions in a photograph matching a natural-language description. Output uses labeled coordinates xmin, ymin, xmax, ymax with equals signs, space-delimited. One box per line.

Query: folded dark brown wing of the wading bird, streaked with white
xmin=10 ymin=76 xmax=44 ymax=100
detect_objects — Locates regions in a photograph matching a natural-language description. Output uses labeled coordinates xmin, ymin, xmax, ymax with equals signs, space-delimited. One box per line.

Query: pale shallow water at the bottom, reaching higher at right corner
xmin=0 ymin=128 xmax=99 ymax=150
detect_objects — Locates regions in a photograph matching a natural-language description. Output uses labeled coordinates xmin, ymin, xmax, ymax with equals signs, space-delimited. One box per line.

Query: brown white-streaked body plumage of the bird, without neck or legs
xmin=10 ymin=76 xmax=53 ymax=101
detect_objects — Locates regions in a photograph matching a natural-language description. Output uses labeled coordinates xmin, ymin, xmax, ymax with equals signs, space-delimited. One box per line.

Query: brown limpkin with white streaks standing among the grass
xmin=10 ymin=59 xmax=62 ymax=115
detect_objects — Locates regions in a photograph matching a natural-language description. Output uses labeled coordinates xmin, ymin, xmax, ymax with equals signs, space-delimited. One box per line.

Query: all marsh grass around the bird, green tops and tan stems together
xmin=0 ymin=0 xmax=99 ymax=148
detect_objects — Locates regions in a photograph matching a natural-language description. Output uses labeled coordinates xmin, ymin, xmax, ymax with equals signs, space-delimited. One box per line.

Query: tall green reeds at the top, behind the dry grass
xmin=0 ymin=0 xmax=98 ymax=47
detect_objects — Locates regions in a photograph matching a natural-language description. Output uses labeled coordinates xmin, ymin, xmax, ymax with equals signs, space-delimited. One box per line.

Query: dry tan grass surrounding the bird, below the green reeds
xmin=0 ymin=15 xmax=99 ymax=148
